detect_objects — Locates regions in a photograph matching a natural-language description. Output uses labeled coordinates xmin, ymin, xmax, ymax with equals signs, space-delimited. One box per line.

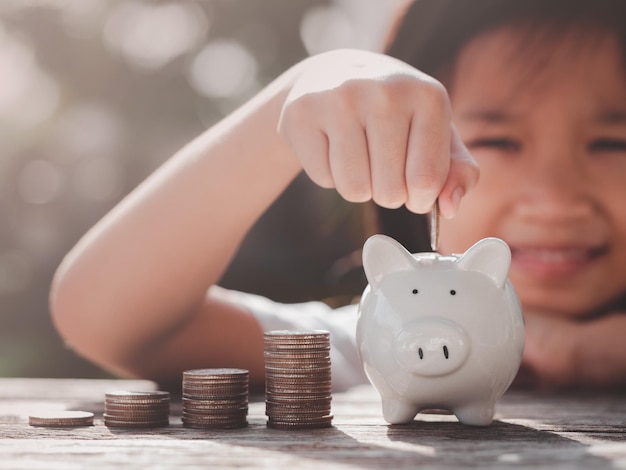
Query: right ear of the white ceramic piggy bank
xmin=457 ymin=238 xmax=511 ymax=287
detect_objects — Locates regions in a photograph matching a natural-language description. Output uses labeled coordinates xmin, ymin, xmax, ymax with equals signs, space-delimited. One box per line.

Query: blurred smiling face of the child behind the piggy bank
xmin=440 ymin=23 xmax=626 ymax=315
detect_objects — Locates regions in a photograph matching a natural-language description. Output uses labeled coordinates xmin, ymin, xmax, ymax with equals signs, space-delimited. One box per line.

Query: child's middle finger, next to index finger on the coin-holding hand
xmin=367 ymin=116 xmax=409 ymax=209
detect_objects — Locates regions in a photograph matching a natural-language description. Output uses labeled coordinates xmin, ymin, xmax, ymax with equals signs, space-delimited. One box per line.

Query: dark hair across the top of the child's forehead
xmin=387 ymin=0 xmax=626 ymax=76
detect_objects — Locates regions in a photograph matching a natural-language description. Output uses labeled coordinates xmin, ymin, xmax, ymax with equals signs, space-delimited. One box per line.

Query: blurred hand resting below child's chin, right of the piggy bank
xmin=523 ymin=312 xmax=626 ymax=388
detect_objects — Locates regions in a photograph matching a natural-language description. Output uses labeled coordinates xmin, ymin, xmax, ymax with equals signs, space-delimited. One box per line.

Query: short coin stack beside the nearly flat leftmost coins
xmin=104 ymin=391 xmax=170 ymax=428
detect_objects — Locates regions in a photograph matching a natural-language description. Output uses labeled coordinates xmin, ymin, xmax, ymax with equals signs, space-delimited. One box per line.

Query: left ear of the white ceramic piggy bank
xmin=363 ymin=235 xmax=417 ymax=287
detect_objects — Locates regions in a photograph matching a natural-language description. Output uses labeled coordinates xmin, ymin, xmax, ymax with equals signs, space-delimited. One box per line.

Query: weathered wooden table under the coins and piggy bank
xmin=0 ymin=379 xmax=626 ymax=470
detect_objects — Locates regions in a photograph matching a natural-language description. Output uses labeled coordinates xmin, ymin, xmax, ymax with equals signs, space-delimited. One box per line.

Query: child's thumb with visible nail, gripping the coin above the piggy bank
xmin=439 ymin=126 xmax=479 ymax=218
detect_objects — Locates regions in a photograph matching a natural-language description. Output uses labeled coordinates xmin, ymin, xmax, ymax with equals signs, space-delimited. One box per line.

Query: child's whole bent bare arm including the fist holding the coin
xmin=51 ymin=51 xmax=477 ymax=382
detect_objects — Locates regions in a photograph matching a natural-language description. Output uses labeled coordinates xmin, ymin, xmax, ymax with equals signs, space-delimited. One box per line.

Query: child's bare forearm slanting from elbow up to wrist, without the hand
xmin=51 ymin=64 xmax=301 ymax=370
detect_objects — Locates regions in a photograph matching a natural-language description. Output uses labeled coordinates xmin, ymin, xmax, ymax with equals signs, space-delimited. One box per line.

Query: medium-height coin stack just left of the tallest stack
xmin=183 ymin=369 xmax=249 ymax=429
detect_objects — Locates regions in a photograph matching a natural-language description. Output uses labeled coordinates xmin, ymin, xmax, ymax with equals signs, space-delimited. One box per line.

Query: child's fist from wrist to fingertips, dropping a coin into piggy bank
xmin=279 ymin=50 xmax=478 ymax=217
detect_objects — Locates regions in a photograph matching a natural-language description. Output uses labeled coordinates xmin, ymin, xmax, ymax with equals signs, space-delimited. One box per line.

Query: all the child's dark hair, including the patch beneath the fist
xmin=376 ymin=0 xmax=626 ymax=252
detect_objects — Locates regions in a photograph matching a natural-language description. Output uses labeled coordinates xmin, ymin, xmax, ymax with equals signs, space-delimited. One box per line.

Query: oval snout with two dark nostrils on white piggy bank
xmin=394 ymin=318 xmax=470 ymax=377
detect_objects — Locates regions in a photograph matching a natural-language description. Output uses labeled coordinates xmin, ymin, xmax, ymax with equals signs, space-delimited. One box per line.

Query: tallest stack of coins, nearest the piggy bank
xmin=265 ymin=330 xmax=333 ymax=429
